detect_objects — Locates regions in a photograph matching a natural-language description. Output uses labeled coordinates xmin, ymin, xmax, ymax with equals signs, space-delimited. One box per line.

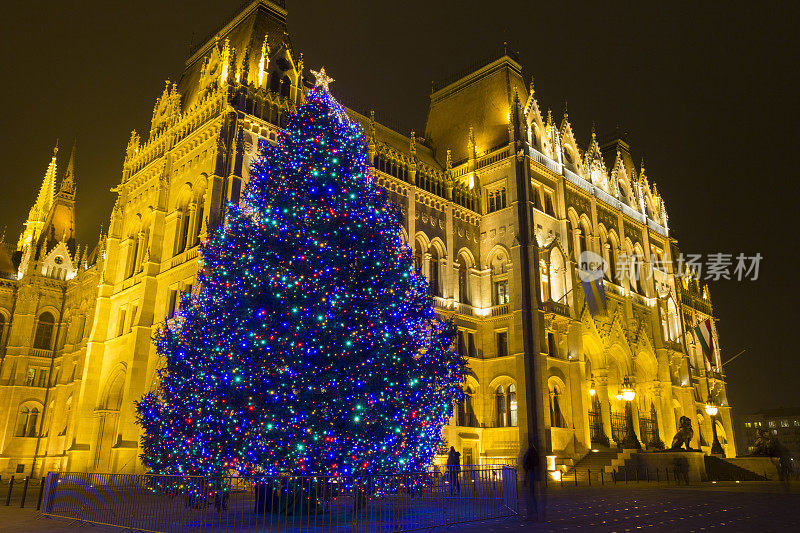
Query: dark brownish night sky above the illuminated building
xmin=0 ymin=0 xmax=800 ymax=413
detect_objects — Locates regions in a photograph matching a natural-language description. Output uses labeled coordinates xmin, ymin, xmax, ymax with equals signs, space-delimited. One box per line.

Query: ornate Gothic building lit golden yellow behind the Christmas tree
xmin=0 ymin=0 xmax=735 ymax=475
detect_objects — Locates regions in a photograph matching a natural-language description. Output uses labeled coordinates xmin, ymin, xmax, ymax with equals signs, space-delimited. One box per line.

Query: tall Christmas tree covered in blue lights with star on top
xmin=137 ymin=69 xmax=465 ymax=476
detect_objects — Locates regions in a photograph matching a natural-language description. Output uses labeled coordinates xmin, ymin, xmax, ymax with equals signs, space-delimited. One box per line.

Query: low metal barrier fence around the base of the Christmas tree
xmin=42 ymin=465 xmax=518 ymax=533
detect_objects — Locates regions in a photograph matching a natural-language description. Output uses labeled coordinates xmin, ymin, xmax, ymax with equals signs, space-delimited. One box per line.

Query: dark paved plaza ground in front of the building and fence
xmin=0 ymin=482 xmax=800 ymax=533
